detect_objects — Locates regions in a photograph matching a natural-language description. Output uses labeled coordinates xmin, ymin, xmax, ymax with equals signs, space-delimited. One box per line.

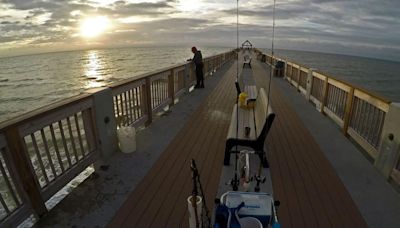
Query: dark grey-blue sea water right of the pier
xmin=274 ymin=50 xmax=400 ymax=102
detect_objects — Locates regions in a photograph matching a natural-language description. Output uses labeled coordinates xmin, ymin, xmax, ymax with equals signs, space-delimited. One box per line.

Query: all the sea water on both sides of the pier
xmin=0 ymin=47 xmax=400 ymax=122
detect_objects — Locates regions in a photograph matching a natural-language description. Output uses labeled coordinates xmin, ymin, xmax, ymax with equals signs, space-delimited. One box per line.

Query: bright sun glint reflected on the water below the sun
xmin=84 ymin=50 xmax=106 ymax=89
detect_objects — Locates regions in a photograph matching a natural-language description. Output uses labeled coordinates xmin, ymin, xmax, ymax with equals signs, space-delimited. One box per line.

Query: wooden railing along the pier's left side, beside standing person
xmin=0 ymin=52 xmax=236 ymax=227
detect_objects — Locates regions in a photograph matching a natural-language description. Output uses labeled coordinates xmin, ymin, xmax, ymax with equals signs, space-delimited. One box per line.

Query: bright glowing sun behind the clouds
xmin=80 ymin=16 xmax=110 ymax=38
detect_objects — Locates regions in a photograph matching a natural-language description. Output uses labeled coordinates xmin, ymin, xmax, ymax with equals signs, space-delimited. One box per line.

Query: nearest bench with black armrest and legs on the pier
xmin=224 ymin=88 xmax=275 ymax=168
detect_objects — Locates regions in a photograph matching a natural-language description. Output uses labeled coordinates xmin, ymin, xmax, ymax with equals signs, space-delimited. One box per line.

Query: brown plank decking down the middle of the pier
xmin=109 ymin=54 xmax=367 ymax=227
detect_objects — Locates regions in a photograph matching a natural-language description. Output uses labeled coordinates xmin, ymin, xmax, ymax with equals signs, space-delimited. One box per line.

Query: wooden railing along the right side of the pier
xmin=258 ymin=52 xmax=400 ymax=183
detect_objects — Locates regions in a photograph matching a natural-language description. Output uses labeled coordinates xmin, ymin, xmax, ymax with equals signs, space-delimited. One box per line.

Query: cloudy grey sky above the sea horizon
xmin=0 ymin=0 xmax=400 ymax=61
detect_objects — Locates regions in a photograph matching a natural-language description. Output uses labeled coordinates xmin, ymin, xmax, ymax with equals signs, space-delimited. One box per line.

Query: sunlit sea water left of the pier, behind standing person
xmin=0 ymin=47 xmax=230 ymax=122
